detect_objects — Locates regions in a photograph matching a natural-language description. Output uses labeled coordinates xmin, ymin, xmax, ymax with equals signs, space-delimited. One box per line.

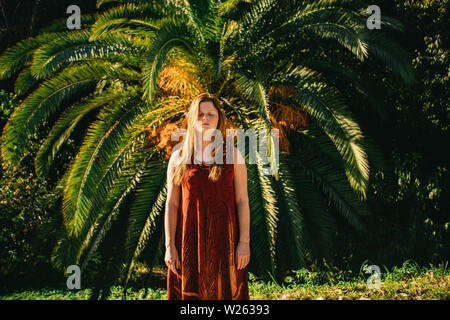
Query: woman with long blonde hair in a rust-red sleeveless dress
xmin=164 ymin=93 xmax=250 ymax=300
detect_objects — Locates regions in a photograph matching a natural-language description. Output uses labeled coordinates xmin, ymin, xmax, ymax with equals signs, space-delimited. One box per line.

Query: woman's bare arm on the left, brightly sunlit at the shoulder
xmin=164 ymin=150 xmax=181 ymax=269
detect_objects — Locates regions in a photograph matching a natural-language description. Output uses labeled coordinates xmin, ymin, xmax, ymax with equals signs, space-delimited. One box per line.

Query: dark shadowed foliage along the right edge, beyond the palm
xmin=335 ymin=0 xmax=450 ymax=269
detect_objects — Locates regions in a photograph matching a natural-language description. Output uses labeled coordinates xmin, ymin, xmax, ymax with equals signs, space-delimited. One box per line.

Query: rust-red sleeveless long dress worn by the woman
xmin=167 ymin=148 xmax=249 ymax=300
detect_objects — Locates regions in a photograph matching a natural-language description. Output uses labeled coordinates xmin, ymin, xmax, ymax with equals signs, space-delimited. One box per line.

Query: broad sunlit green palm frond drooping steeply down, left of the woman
xmin=63 ymin=92 xmax=146 ymax=236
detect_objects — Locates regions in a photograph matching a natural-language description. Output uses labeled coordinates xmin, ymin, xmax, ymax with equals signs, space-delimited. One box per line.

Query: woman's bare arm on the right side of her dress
xmin=234 ymin=148 xmax=250 ymax=269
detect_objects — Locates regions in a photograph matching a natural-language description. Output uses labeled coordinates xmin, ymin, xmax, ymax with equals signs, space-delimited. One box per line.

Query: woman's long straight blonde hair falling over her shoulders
xmin=173 ymin=92 xmax=226 ymax=185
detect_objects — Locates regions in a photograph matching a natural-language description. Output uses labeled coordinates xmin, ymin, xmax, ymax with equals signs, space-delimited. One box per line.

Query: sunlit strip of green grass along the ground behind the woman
xmin=0 ymin=261 xmax=450 ymax=300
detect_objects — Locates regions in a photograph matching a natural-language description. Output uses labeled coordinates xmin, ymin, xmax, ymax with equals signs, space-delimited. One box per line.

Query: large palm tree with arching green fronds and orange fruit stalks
xmin=0 ymin=0 xmax=413 ymax=297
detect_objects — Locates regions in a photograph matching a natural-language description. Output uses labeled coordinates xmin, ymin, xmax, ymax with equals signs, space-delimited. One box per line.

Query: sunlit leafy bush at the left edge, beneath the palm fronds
xmin=0 ymin=90 xmax=61 ymax=290
